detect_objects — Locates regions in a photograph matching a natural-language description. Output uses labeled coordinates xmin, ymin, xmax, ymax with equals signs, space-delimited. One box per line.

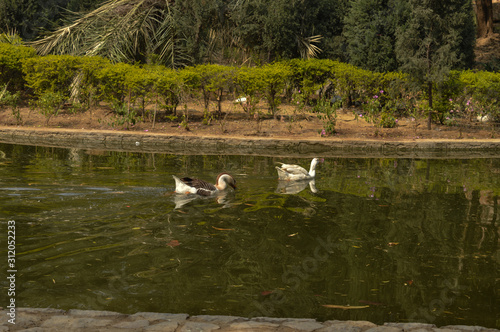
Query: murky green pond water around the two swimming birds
xmin=0 ymin=144 xmax=500 ymax=328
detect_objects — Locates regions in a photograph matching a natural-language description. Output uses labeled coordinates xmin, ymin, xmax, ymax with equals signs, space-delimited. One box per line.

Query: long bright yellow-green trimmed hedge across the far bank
xmin=0 ymin=43 xmax=500 ymax=123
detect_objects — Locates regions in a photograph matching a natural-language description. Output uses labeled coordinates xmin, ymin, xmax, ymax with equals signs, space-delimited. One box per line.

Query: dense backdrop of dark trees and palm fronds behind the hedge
xmin=0 ymin=0 xmax=475 ymax=72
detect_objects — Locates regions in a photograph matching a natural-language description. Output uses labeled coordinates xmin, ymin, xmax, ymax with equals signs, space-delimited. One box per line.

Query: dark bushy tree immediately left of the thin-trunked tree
xmin=343 ymin=0 xmax=410 ymax=72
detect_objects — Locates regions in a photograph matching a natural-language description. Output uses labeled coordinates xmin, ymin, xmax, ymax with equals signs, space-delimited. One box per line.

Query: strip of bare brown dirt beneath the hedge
xmin=0 ymin=101 xmax=500 ymax=141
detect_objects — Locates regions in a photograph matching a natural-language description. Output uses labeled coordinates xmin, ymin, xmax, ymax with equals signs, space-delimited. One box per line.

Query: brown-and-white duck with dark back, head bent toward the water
xmin=172 ymin=173 xmax=236 ymax=196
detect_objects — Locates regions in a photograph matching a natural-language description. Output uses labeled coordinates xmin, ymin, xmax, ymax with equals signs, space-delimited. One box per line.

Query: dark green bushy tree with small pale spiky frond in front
xmin=230 ymin=0 xmax=348 ymax=61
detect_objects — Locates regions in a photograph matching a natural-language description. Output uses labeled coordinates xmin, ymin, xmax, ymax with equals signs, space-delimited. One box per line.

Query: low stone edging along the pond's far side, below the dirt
xmin=0 ymin=127 xmax=500 ymax=159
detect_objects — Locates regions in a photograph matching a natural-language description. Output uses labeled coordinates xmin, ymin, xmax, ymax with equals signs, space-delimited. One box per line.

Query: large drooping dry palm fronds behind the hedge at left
xmin=31 ymin=0 xmax=188 ymax=67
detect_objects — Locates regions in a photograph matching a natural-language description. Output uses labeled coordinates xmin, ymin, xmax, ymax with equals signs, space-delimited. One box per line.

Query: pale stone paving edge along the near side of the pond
xmin=0 ymin=308 xmax=499 ymax=332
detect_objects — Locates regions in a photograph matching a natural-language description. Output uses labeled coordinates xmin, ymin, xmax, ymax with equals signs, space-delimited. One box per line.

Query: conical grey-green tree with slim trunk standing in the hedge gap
xmin=396 ymin=0 xmax=474 ymax=129
